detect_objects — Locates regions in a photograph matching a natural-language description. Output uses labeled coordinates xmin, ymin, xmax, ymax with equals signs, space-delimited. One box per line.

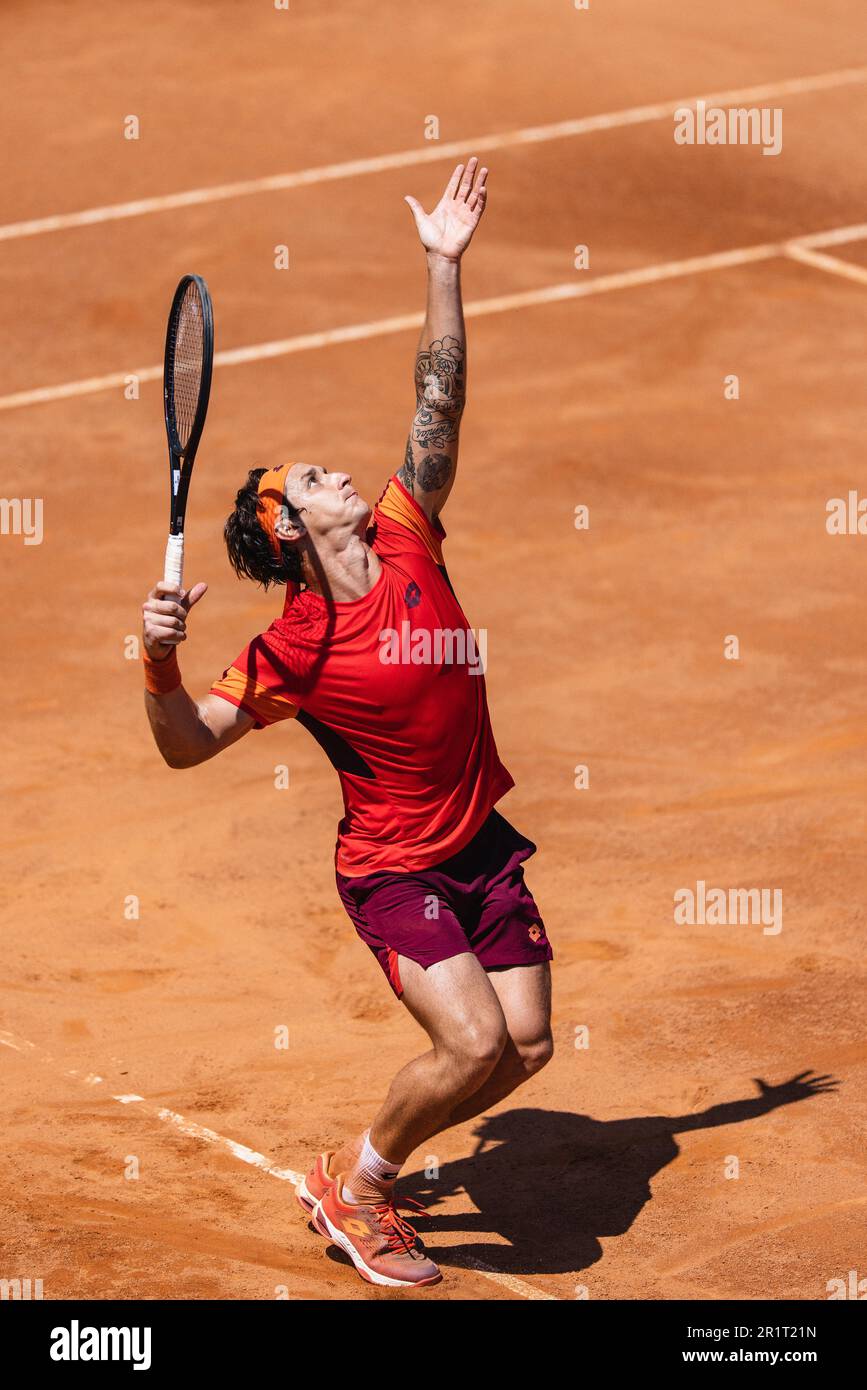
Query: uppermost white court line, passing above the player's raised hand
xmin=0 ymin=67 xmax=867 ymax=242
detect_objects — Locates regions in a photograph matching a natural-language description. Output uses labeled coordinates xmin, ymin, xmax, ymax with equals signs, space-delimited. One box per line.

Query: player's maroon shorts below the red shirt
xmin=338 ymin=810 xmax=553 ymax=998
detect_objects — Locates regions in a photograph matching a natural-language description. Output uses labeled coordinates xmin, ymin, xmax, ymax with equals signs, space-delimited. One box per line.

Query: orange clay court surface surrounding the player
xmin=0 ymin=0 xmax=867 ymax=1300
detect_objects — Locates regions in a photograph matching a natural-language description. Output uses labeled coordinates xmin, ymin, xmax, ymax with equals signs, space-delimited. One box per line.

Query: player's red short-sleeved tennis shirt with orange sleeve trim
xmin=211 ymin=478 xmax=514 ymax=877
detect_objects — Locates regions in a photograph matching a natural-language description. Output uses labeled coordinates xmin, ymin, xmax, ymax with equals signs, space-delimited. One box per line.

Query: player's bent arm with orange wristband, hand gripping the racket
xmin=142 ymin=581 xmax=253 ymax=767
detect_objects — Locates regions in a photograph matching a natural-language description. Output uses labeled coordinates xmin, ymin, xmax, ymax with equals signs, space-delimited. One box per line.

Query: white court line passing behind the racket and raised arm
xmin=0 ymin=222 xmax=867 ymax=410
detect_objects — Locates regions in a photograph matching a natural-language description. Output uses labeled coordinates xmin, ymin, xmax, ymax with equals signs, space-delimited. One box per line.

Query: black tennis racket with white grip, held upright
xmin=163 ymin=275 xmax=214 ymax=585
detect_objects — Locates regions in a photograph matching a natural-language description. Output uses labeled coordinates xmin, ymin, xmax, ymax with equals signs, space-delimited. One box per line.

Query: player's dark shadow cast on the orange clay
xmin=399 ymin=1070 xmax=839 ymax=1275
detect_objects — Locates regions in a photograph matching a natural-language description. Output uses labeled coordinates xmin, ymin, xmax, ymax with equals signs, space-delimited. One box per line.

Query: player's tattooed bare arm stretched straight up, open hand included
xmin=397 ymin=157 xmax=488 ymax=518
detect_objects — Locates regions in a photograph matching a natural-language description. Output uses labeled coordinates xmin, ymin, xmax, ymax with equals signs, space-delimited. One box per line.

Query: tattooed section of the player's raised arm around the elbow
xmin=397 ymin=335 xmax=465 ymax=492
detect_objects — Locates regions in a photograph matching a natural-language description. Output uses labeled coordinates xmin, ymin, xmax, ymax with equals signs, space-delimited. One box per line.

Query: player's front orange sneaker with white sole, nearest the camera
xmin=313 ymin=1176 xmax=442 ymax=1289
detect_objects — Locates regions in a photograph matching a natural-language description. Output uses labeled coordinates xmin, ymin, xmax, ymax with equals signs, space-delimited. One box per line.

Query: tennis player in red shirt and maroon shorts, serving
xmin=143 ymin=158 xmax=552 ymax=1286
